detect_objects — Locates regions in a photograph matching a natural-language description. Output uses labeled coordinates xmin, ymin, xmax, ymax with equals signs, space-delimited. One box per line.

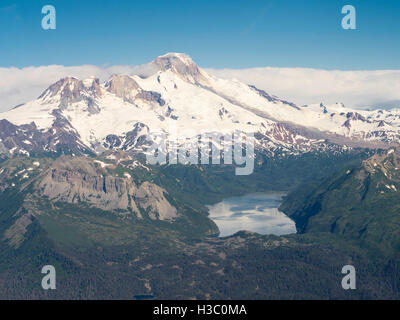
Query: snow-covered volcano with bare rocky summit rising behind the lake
xmin=0 ymin=53 xmax=400 ymax=159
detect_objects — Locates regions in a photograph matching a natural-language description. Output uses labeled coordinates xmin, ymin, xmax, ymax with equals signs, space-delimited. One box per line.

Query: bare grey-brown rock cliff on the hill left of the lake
xmin=38 ymin=157 xmax=178 ymax=220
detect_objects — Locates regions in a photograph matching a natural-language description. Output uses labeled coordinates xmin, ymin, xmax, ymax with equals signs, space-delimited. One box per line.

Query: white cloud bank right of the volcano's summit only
xmin=207 ymin=67 xmax=400 ymax=108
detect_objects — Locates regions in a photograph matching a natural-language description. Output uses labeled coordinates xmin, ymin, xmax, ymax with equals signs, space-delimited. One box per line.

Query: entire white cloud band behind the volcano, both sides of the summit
xmin=0 ymin=65 xmax=400 ymax=112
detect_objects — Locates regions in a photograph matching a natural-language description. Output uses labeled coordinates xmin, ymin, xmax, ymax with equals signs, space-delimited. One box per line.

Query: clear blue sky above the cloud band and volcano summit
xmin=0 ymin=0 xmax=400 ymax=70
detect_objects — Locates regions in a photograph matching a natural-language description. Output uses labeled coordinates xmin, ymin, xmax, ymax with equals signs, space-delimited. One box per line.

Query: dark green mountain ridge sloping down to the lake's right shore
xmin=280 ymin=148 xmax=400 ymax=256
